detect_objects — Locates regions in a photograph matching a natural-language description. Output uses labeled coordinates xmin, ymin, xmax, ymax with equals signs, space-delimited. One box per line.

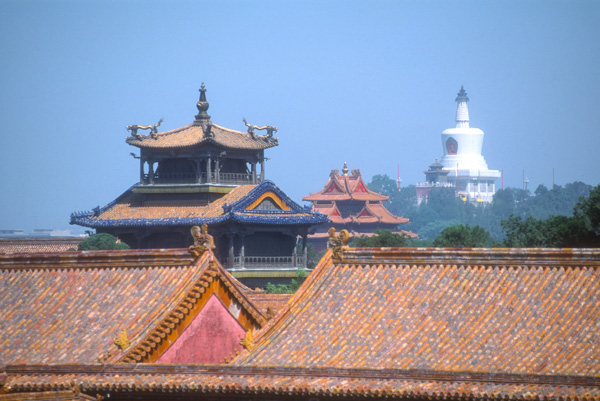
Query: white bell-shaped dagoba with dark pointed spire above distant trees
xmin=440 ymin=86 xmax=500 ymax=203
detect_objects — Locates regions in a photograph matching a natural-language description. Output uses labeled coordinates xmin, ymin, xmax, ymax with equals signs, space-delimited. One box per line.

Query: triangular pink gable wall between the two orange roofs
xmin=156 ymin=294 xmax=246 ymax=363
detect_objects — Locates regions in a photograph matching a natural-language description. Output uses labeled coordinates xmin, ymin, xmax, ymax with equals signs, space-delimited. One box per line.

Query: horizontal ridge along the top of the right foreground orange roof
xmin=343 ymin=248 xmax=600 ymax=268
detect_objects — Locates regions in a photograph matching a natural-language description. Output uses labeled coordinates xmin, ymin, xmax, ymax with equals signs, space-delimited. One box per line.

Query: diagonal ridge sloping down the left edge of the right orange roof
xmin=233 ymin=249 xmax=333 ymax=364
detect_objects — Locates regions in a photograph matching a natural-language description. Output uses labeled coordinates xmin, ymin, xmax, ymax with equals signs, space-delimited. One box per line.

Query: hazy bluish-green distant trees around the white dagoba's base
xmin=368 ymin=175 xmax=600 ymax=243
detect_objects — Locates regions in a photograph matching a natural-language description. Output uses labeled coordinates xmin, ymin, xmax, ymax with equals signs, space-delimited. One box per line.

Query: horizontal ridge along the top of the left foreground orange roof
xmin=0 ymin=249 xmax=192 ymax=270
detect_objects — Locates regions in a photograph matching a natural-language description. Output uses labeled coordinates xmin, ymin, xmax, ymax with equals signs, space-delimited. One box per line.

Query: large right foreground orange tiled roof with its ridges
xmin=235 ymin=248 xmax=600 ymax=377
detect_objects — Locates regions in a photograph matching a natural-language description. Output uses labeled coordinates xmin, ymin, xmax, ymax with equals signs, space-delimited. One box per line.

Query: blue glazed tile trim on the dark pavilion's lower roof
xmin=70 ymin=181 xmax=329 ymax=228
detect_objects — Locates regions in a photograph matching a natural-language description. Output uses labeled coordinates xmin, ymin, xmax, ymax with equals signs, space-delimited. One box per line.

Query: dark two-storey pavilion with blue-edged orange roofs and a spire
xmin=71 ymin=85 xmax=328 ymax=280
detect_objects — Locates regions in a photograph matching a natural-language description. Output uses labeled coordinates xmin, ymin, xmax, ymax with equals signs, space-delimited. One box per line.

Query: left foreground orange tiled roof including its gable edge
xmin=0 ymin=250 xmax=266 ymax=373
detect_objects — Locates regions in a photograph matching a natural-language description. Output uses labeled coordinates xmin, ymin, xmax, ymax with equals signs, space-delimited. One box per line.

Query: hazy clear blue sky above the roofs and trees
xmin=0 ymin=0 xmax=600 ymax=230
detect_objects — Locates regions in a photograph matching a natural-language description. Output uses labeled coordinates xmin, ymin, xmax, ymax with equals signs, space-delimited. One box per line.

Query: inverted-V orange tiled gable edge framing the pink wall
xmin=118 ymin=250 xmax=266 ymax=363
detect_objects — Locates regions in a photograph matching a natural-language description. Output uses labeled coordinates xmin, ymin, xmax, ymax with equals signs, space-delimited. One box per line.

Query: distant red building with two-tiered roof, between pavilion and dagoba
xmin=302 ymin=163 xmax=414 ymax=248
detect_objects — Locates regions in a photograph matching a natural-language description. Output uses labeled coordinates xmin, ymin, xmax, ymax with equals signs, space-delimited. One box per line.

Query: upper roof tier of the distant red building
xmin=302 ymin=163 xmax=389 ymax=202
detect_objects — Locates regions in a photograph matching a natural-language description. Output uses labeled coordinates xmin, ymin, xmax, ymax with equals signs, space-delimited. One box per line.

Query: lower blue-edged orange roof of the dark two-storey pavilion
xmin=71 ymin=180 xmax=329 ymax=228
